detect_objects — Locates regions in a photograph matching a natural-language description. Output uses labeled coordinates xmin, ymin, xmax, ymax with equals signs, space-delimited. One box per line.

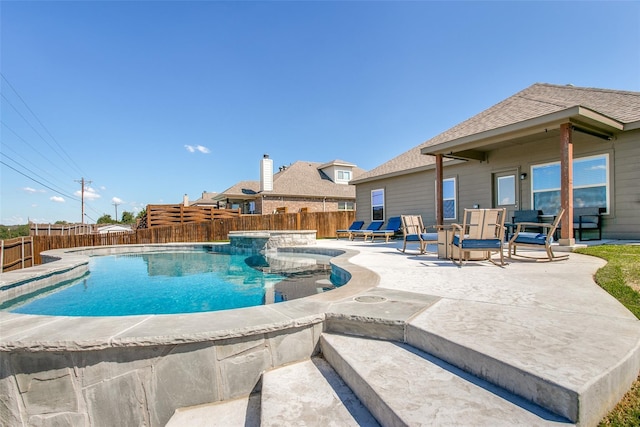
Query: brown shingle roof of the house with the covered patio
xmin=354 ymin=83 xmax=640 ymax=183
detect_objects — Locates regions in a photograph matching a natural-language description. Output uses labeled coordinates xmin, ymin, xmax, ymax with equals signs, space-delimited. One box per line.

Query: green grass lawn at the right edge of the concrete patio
xmin=576 ymin=245 xmax=640 ymax=426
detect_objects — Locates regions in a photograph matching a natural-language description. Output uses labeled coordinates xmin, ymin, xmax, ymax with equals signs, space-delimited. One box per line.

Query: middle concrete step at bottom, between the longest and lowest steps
xmin=260 ymin=357 xmax=379 ymax=427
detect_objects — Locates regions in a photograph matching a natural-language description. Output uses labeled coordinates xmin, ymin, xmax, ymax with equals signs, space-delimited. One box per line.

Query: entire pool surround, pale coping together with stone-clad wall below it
xmin=0 ymin=235 xmax=378 ymax=426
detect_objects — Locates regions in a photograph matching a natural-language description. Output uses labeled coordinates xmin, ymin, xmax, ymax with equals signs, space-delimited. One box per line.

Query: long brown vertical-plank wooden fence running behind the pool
xmin=25 ymin=211 xmax=355 ymax=264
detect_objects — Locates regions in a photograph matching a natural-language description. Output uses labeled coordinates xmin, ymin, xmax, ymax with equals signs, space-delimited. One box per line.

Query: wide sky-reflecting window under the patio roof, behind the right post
xmin=531 ymin=154 xmax=610 ymax=214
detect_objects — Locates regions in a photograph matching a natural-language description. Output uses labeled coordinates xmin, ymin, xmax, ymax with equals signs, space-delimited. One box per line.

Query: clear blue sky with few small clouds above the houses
xmin=0 ymin=1 xmax=640 ymax=225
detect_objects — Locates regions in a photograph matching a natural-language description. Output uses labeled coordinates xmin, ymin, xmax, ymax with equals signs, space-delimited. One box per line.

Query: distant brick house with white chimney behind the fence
xmin=214 ymin=154 xmax=365 ymax=214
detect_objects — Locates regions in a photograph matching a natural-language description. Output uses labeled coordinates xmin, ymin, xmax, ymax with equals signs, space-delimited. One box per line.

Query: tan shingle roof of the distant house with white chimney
xmin=218 ymin=160 xmax=365 ymax=199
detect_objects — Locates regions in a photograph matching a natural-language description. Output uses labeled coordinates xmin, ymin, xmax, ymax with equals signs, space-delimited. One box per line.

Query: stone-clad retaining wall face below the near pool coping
xmin=0 ymin=317 xmax=323 ymax=427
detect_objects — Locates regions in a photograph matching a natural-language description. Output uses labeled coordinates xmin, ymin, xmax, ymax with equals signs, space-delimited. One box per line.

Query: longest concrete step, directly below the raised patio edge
xmin=321 ymin=333 xmax=570 ymax=426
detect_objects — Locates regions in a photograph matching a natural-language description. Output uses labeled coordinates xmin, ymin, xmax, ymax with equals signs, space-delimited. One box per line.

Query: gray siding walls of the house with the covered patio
xmin=356 ymin=131 xmax=640 ymax=239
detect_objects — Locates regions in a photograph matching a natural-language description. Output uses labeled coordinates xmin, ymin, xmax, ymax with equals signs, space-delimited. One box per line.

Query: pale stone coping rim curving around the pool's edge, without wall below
xmin=0 ymin=242 xmax=380 ymax=352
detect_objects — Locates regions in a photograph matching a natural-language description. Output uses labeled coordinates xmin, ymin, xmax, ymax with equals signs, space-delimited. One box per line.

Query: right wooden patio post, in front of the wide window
xmin=560 ymin=123 xmax=576 ymax=246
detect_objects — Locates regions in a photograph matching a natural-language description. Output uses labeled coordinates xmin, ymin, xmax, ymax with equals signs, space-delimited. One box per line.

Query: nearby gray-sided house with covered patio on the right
xmin=352 ymin=84 xmax=640 ymax=244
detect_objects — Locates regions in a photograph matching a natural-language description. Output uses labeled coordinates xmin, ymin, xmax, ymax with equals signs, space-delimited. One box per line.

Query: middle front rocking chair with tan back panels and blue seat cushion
xmin=451 ymin=209 xmax=507 ymax=266
